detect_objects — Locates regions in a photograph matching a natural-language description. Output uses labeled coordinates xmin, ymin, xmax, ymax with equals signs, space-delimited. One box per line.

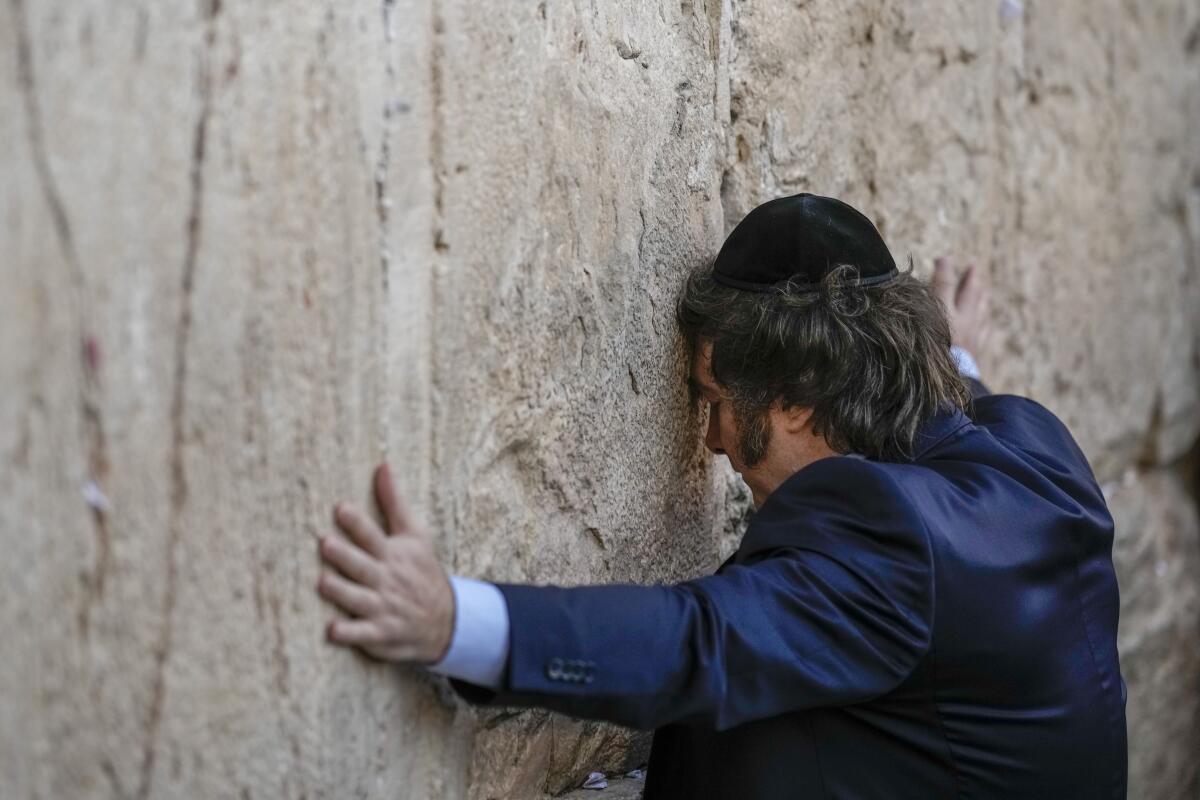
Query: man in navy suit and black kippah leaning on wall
xmin=319 ymin=194 xmax=1126 ymax=800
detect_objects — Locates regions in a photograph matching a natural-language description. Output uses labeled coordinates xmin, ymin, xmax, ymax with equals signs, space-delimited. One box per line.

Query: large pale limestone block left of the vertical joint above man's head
xmin=0 ymin=1 xmax=728 ymax=798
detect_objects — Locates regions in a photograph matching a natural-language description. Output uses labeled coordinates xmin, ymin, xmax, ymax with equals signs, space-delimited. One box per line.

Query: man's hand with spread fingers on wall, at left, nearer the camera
xmin=317 ymin=464 xmax=455 ymax=663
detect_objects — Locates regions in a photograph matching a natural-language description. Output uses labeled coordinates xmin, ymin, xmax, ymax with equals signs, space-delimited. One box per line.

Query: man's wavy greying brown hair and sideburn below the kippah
xmin=676 ymin=260 xmax=971 ymax=463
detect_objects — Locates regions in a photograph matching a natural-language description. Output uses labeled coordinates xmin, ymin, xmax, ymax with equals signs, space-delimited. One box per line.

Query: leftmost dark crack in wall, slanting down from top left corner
xmin=11 ymin=0 xmax=112 ymax=638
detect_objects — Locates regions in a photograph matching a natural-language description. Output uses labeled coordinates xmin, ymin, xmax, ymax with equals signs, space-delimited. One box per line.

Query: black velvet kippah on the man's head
xmin=713 ymin=193 xmax=899 ymax=293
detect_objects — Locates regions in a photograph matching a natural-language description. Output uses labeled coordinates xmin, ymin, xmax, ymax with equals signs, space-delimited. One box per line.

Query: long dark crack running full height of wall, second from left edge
xmin=137 ymin=0 xmax=221 ymax=800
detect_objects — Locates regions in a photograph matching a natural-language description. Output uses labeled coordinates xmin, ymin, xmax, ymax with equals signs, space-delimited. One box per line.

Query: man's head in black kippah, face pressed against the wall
xmin=677 ymin=198 xmax=971 ymax=504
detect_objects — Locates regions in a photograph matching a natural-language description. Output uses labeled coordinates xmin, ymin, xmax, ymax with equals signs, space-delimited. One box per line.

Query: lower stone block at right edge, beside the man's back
xmin=1104 ymin=462 xmax=1200 ymax=800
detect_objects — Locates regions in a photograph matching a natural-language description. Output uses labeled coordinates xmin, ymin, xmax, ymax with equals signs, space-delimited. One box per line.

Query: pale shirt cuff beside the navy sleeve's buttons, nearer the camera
xmin=428 ymin=575 xmax=509 ymax=688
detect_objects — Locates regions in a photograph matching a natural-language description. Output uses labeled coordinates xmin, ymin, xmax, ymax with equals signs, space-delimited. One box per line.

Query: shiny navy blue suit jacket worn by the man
xmin=455 ymin=383 xmax=1126 ymax=800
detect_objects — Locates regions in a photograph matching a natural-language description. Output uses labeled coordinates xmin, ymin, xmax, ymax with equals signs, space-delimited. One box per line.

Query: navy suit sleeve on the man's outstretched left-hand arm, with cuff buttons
xmin=455 ymin=457 xmax=932 ymax=730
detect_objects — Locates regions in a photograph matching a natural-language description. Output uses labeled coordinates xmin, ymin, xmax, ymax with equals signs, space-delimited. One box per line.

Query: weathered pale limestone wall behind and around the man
xmin=0 ymin=0 xmax=1200 ymax=799
